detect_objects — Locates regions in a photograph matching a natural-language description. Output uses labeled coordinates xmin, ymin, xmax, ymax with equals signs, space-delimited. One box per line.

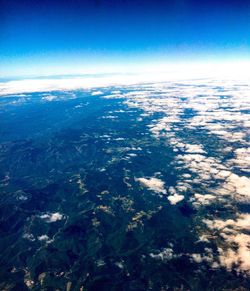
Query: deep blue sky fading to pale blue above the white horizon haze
xmin=0 ymin=0 xmax=250 ymax=75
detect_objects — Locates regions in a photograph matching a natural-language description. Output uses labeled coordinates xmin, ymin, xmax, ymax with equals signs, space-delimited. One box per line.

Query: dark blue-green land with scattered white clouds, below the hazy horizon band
xmin=0 ymin=80 xmax=250 ymax=291
